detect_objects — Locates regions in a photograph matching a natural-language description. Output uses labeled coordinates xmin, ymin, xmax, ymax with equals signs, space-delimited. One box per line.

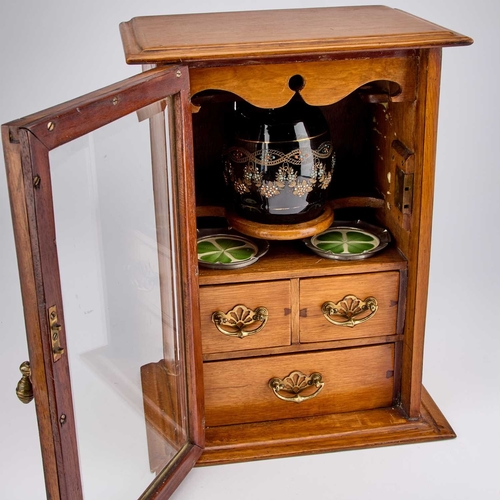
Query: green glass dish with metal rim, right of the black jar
xmin=304 ymin=220 xmax=391 ymax=260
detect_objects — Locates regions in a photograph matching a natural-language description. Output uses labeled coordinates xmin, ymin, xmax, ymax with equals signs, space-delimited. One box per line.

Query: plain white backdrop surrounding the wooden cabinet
xmin=0 ymin=0 xmax=500 ymax=500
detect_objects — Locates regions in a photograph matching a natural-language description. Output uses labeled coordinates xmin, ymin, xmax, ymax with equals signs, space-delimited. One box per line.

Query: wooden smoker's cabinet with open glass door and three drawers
xmin=2 ymin=6 xmax=472 ymax=500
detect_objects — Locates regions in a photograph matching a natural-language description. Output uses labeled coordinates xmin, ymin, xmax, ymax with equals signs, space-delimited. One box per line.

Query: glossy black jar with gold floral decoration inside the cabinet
xmin=224 ymin=95 xmax=335 ymax=224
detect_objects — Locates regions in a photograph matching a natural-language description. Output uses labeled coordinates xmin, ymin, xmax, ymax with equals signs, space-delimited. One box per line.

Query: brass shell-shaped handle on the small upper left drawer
xmin=212 ymin=304 xmax=269 ymax=339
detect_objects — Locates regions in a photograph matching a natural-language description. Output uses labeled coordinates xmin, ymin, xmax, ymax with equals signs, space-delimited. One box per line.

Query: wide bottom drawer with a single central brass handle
xmin=203 ymin=343 xmax=394 ymax=427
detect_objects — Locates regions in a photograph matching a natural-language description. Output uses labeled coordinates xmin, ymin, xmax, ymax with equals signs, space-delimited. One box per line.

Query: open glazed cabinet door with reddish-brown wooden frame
xmin=2 ymin=66 xmax=204 ymax=500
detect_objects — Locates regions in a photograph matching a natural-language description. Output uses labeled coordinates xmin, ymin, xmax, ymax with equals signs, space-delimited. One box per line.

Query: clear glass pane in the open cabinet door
xmin=50 ymin=98 xmax=188 ymax=500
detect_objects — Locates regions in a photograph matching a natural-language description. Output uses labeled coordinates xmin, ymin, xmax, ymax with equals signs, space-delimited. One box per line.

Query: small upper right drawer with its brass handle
xmin=299 ymin=271 xmax=399 ymax=343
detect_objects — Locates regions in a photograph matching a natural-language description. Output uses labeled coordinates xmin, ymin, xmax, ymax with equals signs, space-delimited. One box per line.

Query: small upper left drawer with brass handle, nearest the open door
xmin=200 ymin=280 xmax=291 ymax=354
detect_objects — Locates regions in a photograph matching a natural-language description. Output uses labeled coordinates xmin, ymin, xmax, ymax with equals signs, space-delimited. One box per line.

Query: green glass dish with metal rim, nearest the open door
xmin=197 ymin=233 xmax=269 ymax=269
